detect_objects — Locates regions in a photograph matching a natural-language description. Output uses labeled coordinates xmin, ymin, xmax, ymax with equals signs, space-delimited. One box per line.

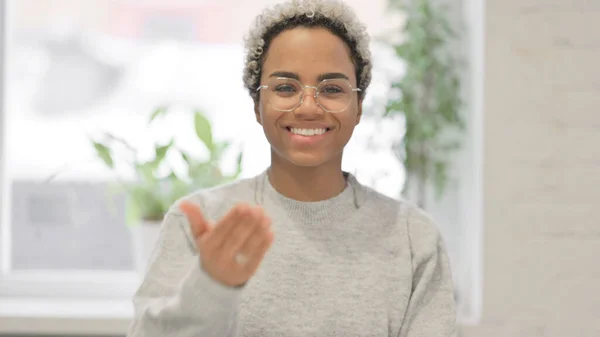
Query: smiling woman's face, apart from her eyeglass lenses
xmin=255 ymin=27 xmax=362 ymax=167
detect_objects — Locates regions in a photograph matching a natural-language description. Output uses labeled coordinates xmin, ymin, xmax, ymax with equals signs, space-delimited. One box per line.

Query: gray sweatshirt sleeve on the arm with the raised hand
xmin=127 ymin=212 xmax=241 ymax=337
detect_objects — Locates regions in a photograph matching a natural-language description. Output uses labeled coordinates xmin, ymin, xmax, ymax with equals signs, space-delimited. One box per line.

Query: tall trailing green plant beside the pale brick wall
xmin=385 ymin=0 xmax=465 ymax=207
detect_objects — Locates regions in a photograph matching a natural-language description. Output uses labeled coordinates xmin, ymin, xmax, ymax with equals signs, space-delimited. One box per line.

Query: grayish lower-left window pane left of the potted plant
xmin=12 ymin=179 xmax=132 ymax=270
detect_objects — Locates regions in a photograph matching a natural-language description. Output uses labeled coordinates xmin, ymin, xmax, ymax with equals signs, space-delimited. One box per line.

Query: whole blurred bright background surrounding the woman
xmin=0 ymin=0 xmax=600 ymax=337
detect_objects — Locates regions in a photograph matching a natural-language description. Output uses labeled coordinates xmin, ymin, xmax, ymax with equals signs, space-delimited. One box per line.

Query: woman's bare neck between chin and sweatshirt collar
xmin=268 ymin=155 xmax=346 ymax=201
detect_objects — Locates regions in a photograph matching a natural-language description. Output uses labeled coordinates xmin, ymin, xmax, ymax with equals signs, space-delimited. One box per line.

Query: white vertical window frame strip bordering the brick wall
xmin=458 ymin=0 xmax=486 ymax=326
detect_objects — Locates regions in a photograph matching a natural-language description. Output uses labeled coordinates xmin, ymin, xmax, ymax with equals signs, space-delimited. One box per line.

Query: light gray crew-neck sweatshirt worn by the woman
xmin=128 ymin=172 xmax=456 ymax=337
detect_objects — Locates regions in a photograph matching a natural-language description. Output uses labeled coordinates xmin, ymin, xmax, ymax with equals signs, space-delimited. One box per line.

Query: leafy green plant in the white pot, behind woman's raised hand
xmin=91 ymin=107 xmax=242 ymax=223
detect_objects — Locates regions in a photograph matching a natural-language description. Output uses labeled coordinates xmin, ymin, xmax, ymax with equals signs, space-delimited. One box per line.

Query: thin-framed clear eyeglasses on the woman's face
xmin=256 ymin=77 xmax=360 ymax=113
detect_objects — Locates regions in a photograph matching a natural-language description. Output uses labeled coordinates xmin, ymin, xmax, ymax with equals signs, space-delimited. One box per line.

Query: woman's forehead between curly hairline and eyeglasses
xmin=262 ymin=27 xmax=356 ymax=84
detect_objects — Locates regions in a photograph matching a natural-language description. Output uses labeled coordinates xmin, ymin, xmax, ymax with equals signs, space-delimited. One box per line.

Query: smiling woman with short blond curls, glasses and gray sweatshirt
xmin=129 ymin=0 xmax=455 ymax=337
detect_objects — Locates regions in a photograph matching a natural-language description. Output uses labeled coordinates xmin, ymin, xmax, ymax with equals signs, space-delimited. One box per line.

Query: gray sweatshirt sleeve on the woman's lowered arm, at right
xmin=399 ymin=208 xmax=457 ymax=337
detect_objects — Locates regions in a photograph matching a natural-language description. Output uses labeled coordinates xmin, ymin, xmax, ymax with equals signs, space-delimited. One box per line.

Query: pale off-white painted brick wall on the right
xmin=462 ymin=0 xmax=600 ymax=337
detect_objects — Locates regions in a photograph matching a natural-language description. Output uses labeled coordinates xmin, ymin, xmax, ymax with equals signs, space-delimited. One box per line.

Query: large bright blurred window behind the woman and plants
xmin=0 ymin=0 xmax=480 ymax=326
